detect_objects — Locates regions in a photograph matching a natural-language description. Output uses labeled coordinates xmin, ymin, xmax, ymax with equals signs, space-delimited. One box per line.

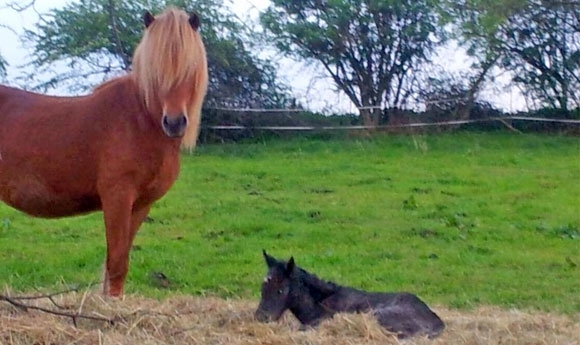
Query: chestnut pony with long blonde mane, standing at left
xmin=0 ymin=8 xmax=208 ymax=296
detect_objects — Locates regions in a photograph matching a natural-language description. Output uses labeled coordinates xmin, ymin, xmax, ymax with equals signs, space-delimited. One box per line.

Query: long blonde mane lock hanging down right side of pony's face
xmin=181 ymin=47 xmax=208 ymax=152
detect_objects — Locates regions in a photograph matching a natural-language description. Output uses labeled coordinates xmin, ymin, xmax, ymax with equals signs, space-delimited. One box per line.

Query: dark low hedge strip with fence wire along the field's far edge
xmin=200 ymin=108 xmax=580 ymax=143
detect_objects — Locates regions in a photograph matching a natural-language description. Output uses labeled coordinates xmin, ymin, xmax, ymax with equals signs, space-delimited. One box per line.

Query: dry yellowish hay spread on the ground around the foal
xmin=0 ymin=292 xmax=580 ymax=345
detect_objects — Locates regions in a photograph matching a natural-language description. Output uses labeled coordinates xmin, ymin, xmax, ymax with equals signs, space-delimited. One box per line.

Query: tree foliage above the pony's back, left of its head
xmin=25 ymin=0 xmax=144 ymax=92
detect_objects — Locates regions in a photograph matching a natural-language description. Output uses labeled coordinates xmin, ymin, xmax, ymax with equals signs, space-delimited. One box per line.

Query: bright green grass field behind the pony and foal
xmin=0 ymin=133 xmax=580 ymax=313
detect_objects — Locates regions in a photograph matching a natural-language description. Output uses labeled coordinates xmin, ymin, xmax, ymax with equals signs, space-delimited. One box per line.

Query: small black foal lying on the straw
xmin=255 ymin=251 xmax=445 ymax=339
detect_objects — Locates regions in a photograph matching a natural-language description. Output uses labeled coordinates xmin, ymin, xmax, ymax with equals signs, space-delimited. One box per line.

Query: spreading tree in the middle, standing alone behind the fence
xmin=261 ymin=0 xmax=441 ymax=125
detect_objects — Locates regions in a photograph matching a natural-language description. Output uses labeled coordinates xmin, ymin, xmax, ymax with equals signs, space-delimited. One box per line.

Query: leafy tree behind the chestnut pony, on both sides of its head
xmin=25 ymin=0 xmax=291 ymax=108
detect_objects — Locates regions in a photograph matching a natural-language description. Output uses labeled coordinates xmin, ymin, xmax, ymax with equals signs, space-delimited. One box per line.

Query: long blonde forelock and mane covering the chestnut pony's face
xmin=132 ymin=7 xmax=208 ymax=149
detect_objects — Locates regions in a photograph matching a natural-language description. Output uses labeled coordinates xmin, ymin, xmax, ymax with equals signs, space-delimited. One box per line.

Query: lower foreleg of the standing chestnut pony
xmin=103 ymin=194 xmax=150 ymax=296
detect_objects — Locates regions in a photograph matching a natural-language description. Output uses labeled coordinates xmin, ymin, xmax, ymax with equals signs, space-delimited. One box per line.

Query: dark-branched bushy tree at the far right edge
xmin=497 ymin=0 xmax=580 ymax=110
